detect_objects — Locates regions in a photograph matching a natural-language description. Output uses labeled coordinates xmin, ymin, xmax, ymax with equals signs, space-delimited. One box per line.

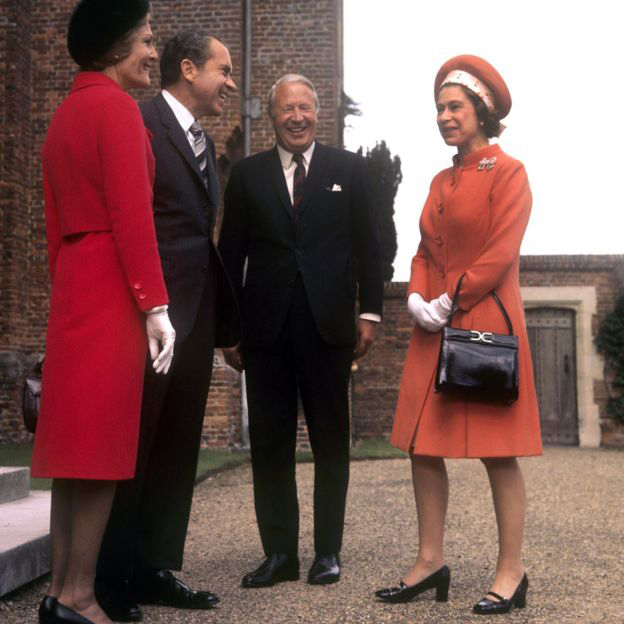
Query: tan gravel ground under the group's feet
xmin=0 ymin=448 xmax=624 ymax=624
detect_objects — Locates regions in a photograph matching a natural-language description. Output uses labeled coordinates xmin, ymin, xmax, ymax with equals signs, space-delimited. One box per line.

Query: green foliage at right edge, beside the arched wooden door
xmin=595 ymin=292 xmax=624 ymax=422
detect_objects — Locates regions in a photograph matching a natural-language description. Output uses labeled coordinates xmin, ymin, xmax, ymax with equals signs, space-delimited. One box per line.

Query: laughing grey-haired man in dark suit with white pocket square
xmin=219 ymin=74 xmax=383 ymax=587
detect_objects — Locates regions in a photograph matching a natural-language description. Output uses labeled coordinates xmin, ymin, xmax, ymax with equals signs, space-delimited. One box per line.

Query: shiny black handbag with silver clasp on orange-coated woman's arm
xmin=435 ymin=275 xmax=518 ymax=403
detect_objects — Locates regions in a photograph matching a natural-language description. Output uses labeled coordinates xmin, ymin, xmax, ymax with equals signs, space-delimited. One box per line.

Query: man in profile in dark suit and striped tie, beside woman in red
xmin=96 ymin=31 xmax=239 ymax=621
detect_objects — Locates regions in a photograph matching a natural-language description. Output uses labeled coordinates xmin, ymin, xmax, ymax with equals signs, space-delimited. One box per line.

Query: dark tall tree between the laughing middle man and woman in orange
xmin=358 ymin=141 xmax=403 ymax=282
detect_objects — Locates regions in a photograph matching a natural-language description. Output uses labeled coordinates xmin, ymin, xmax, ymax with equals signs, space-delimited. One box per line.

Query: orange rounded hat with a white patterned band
xmin=433 ymin=54 xmax=511 ymax=119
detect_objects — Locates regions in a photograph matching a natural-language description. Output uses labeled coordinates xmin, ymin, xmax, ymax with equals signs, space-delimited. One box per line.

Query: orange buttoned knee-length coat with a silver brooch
xmin=390 ymin=145 xmax=542 ymax=457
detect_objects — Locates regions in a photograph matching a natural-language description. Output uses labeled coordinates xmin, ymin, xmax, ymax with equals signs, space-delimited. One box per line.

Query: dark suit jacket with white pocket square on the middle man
xmin=219 ymin=142 xmax=383 ymax=347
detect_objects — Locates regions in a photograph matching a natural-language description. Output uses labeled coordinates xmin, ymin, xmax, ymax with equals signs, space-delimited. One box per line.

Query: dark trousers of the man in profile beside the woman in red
xmin=97 ymin=277 xmax=215 ymax=580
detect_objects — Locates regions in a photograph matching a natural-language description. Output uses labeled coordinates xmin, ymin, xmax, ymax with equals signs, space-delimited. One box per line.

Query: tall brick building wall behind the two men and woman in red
xmin=0 ymin=0 xmax=342 ymax=446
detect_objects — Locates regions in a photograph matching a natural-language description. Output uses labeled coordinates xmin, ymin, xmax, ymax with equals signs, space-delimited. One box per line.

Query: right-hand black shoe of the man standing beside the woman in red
xmin=132 ymin=570 xmax=219 ymax=609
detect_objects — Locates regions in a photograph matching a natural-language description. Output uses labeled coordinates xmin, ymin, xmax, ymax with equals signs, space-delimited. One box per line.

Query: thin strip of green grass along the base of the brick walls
xmin=0 ymin=439 xmax=406 ymax=490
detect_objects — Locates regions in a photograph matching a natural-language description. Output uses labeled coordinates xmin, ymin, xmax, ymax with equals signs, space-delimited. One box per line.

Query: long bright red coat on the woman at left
xmin=32 ymin=72 xmax=168 ymax=479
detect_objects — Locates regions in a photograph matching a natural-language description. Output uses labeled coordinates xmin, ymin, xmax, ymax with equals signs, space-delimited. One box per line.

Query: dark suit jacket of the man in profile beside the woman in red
xmin=139 ymin=94 xmax=240 ymax=346
